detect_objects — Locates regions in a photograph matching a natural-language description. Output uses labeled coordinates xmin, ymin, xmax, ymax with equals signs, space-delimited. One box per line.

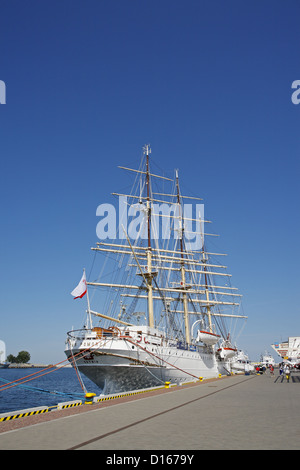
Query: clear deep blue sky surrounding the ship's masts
xmin=0 ymin=0 xmax=300 ymax=363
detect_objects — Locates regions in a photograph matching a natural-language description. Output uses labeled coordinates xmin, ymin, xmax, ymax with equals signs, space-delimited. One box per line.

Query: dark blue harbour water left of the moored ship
xmin=0 ymin=368 xmax=101 ymax=413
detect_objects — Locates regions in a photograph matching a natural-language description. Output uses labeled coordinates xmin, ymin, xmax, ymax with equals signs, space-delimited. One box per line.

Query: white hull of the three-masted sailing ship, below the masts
xmin=65 ymin=327 xmax=229 ymax=394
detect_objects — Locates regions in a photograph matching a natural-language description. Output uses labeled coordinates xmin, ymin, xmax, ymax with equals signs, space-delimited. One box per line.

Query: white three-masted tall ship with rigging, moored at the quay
xmin=65 ymin=145 xmax=247 ymax=394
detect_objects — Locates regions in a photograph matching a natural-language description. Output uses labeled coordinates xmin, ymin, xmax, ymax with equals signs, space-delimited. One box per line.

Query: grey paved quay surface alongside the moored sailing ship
xmin=0 ymin=373 xmax=300 ymax=452
